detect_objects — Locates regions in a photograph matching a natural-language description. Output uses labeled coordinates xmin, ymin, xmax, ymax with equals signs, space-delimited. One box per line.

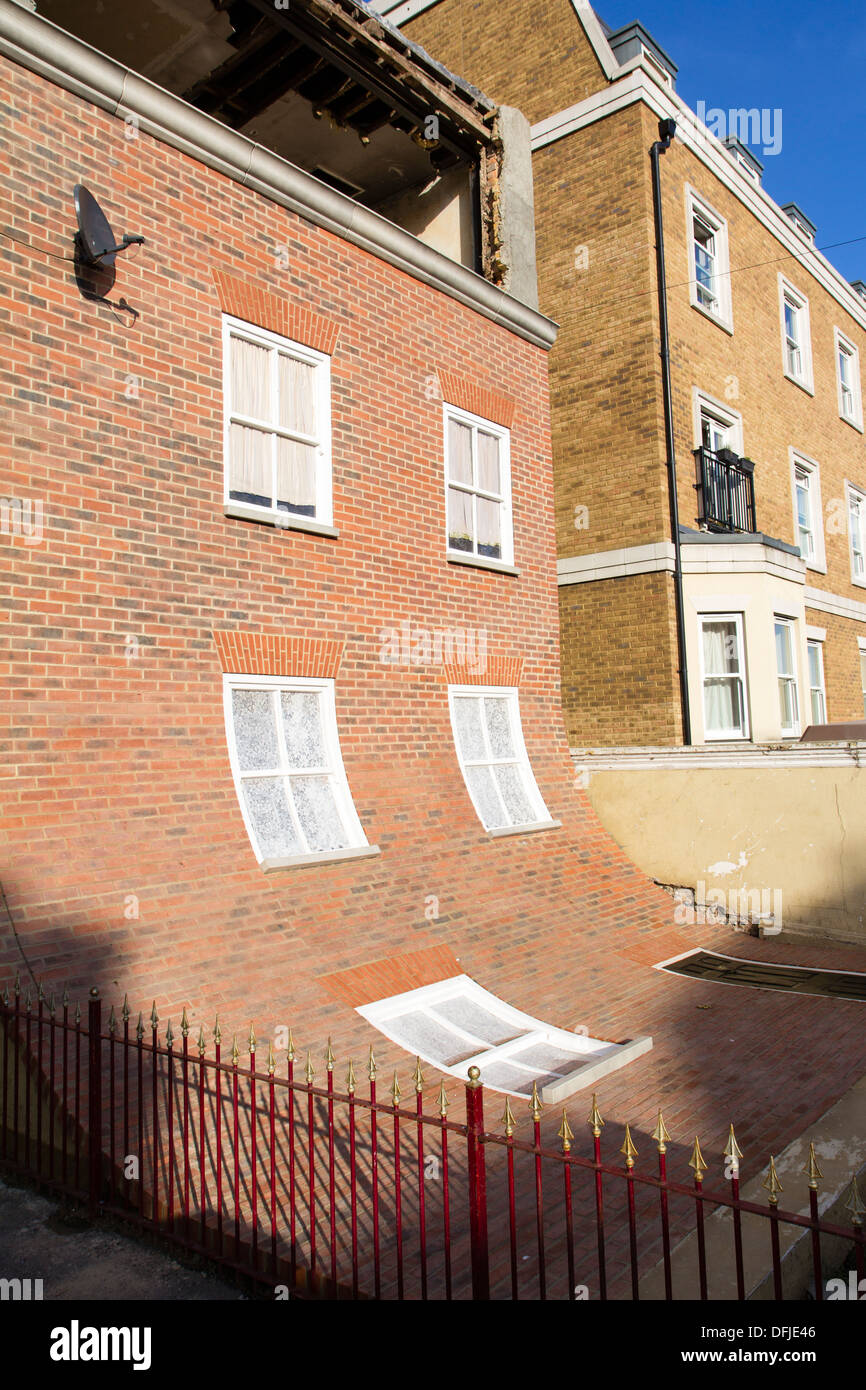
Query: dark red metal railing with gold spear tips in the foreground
xmin=0 ymin=980 xmax=866 ymax=1300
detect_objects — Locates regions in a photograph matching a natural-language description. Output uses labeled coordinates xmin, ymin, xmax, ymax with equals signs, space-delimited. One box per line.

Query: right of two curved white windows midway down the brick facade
xmin=448 ymin=685 xmax=553 ymax=831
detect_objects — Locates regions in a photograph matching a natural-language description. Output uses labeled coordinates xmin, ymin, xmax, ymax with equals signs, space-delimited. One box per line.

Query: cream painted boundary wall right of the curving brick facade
xmin=584 ymin=766 xmax=866 ymax=942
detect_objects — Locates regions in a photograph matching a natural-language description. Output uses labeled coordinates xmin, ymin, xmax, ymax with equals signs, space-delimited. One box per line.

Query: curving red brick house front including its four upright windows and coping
xmin=0 ymin=4 xmax=670 ymax=1106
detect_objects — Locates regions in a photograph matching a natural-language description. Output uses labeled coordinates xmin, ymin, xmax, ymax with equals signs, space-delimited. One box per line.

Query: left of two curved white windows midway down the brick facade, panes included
xmin=224 ymin=676 xmax=367 ymax=867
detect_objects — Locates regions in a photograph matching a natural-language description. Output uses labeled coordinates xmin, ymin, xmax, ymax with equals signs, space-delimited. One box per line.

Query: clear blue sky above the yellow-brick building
xmin=595 ymin=0 xmax=866 ymax=281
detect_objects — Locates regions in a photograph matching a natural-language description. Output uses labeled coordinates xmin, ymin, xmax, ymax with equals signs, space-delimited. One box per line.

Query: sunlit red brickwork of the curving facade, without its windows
xmin=0 ymin=51 xmax=670 ymax=1045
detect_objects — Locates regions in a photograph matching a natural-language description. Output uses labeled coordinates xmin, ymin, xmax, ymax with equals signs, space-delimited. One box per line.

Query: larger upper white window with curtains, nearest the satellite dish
xmin=222 ymin=316 xmax=332 ymax=525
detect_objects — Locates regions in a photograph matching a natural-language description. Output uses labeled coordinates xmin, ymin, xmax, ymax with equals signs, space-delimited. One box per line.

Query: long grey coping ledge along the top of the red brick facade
xmin=0 ymin=0 xmax=557 ymax=349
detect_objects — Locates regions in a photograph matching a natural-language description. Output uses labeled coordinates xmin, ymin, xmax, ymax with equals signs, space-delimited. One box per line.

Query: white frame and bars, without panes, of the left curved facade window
xmin=222 ymin=671 xmax=369 ymax=872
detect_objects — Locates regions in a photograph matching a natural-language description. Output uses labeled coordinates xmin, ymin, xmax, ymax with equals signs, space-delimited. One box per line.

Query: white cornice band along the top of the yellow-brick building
xmin=530 ymin=73 xmax=866 ymax=331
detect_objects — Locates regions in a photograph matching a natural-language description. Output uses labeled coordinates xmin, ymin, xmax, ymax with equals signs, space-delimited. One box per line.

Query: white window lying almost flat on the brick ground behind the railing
xmin=357 ymin=974 xmax=652 ymax=1104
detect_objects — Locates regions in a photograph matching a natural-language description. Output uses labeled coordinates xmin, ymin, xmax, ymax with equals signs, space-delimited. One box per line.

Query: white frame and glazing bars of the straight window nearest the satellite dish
xmin=222 ymin=314 xmax=336 ymax=535
